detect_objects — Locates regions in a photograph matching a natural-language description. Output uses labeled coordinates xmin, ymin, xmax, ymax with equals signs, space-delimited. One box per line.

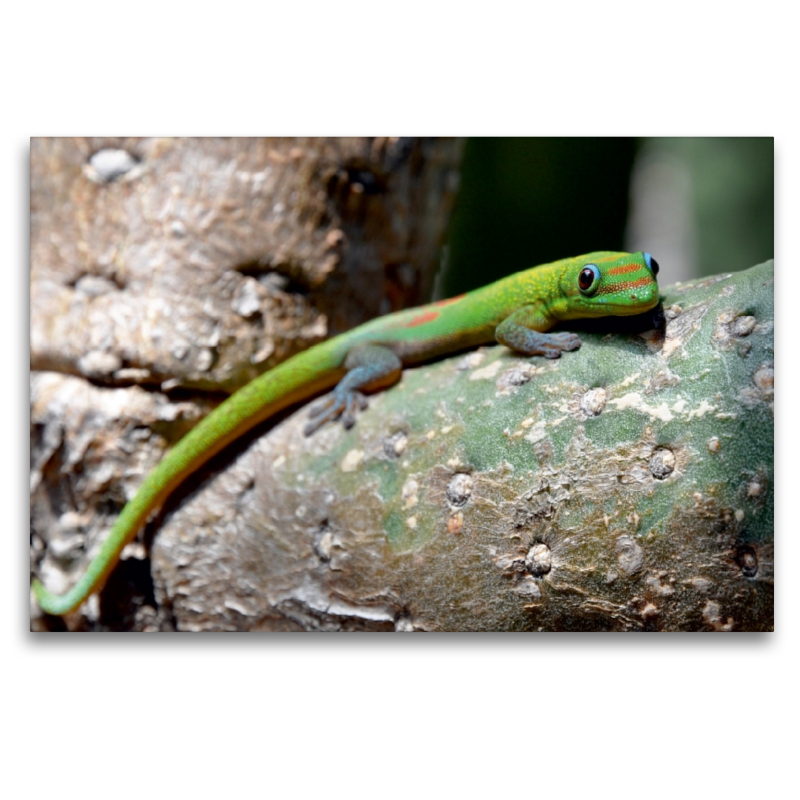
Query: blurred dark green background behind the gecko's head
xmin=436 ymin=137 xmax=774 ymax=297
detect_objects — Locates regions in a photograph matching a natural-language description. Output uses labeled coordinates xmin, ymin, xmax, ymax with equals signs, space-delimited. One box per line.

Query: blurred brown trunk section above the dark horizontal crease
xmin=31 ymin=139 xmax=461 ymax=390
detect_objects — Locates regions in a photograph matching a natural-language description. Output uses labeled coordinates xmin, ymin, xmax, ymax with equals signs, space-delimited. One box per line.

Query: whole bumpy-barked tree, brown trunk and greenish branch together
xmin=31 ymin=140 xmax=774 ymax=631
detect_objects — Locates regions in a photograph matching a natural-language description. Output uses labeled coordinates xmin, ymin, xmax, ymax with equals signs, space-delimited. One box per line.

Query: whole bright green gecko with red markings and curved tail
xmin=32 ymin=252 xmax=658 ymax=615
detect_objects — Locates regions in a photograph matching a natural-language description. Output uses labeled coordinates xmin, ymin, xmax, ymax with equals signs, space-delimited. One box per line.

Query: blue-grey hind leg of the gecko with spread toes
xmin=303 ymin=344 xmax=403 ymax=436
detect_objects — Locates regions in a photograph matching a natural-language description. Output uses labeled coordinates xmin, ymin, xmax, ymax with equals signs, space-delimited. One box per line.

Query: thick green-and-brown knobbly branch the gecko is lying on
xmin=141 ymin=262 xmax=774 ymax=631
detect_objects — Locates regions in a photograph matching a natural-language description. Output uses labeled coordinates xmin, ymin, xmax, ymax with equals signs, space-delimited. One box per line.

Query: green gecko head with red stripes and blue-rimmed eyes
xmin=557 ymin=252 xmax=658 ymax=319
